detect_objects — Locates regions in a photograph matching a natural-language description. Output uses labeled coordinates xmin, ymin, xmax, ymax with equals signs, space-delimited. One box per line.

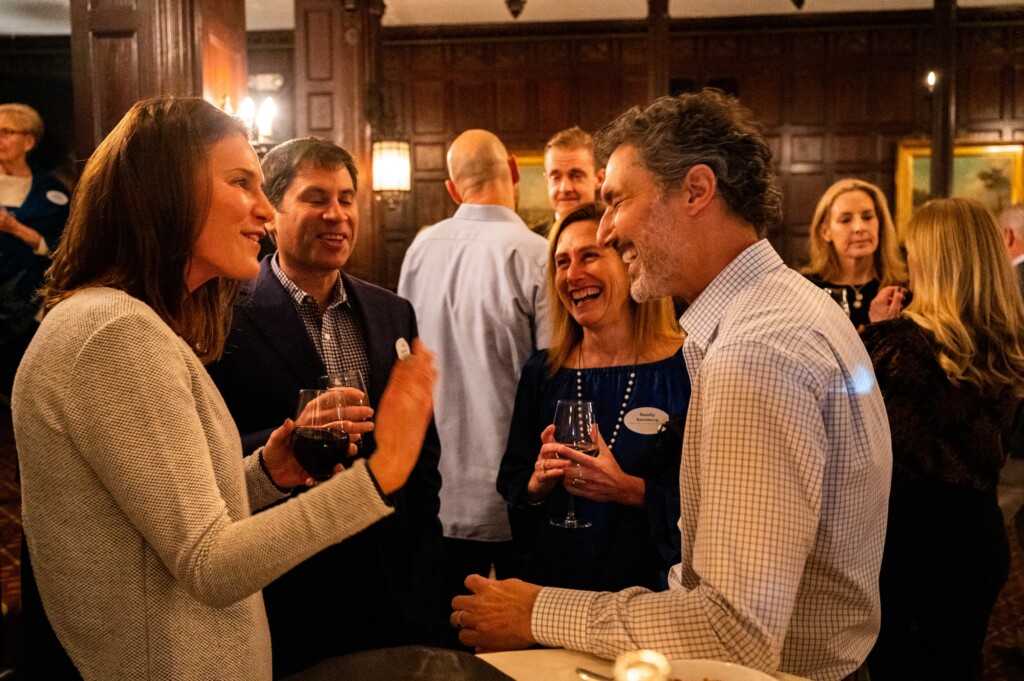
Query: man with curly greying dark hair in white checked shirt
xmin=452 ymin=91 xmax=892 ymax=681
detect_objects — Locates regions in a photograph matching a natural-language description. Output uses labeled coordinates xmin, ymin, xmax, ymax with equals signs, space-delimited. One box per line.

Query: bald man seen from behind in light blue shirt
xmin=398 ymin=130 xmax=550 ymax=610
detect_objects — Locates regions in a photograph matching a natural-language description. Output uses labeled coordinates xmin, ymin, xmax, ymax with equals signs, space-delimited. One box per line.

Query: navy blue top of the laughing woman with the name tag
xmin=498 ymin=350 xmax=690 ymax=591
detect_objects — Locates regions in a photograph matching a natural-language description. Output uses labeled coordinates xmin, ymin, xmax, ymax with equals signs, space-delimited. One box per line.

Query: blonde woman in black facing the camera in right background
xmin=803 ymin=178 xmax=906 ymax=329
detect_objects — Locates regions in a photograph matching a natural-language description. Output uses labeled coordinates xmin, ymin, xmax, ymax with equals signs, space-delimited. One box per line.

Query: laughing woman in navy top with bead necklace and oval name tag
xmin=498 ymin=204 xmax=690 ymax=590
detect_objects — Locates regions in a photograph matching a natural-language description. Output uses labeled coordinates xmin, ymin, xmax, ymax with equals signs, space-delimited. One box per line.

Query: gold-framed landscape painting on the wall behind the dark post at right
xmin=895 ymin=139 xmax=1024 ymax=231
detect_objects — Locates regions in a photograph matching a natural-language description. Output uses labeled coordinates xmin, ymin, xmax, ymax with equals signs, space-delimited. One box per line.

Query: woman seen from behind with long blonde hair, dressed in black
xmin=862 ymin=199 xmax=1024 ymax=681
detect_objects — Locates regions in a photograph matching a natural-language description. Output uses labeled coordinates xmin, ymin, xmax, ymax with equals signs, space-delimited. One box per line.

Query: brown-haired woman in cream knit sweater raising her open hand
xmin=13 ymin=97 xmax=434 ymax=680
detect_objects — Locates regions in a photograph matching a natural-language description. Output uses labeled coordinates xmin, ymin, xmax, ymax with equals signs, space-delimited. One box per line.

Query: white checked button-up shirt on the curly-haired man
xmin=531 ymin=241 xmax=892 ymax=680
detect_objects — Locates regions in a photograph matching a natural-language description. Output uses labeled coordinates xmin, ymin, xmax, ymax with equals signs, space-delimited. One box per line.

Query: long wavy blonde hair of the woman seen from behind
xmin=903 ymin=199 xmax=1024 ymax=394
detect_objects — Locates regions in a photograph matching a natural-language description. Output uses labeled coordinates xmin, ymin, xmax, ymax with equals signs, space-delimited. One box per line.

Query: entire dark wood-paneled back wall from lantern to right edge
xmin=382 ymin=10 xmax=1024 ymax=286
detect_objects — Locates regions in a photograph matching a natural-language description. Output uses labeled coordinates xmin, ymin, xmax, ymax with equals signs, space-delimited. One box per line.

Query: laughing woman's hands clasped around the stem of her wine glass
xmin=526 ymin=425 xmax=644 ymax=506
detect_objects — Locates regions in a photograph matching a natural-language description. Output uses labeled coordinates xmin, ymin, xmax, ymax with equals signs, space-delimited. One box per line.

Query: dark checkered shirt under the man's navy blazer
xmin=270 ymin=255 xmax=370 ymax=387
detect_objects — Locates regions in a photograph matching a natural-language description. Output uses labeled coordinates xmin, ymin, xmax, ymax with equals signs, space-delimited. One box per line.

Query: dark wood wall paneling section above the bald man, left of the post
xmin=381 ymin=25 xmax=648 ymax=287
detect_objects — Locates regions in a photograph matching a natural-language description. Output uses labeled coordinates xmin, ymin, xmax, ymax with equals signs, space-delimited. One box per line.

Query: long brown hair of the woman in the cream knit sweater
xmin=43 ymin=97 xmax=247 ymax=361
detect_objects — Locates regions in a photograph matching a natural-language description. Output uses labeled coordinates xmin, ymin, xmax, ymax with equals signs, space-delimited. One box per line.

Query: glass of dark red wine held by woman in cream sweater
xmin=292 ymin=388 xmax=348 ymax=480
